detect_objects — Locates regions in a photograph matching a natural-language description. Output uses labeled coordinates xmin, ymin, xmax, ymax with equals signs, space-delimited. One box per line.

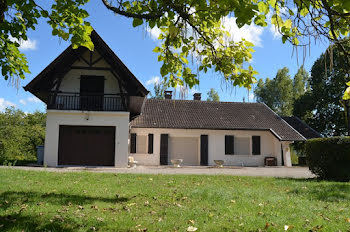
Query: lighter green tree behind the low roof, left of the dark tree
xmin=254 ymin=67 xmax=294 ymax=116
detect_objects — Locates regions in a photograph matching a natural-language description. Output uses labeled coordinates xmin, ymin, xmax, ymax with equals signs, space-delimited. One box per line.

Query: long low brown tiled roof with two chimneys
xmin=131 ymin=99 xmax=305 ymax=141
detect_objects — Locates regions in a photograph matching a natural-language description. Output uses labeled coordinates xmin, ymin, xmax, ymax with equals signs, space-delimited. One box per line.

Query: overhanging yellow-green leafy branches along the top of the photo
xmin=0 ymin=0 xmax=350 ymax=88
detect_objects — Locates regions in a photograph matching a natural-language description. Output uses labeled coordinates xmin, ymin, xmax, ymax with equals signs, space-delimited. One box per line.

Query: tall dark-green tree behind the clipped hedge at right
xmin=294 ymin=42 xmax=350 ymax=136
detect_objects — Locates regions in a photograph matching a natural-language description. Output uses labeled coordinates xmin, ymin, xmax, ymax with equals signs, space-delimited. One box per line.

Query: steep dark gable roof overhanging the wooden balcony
xmin=24 ymin=30 xmax=148 ymax=102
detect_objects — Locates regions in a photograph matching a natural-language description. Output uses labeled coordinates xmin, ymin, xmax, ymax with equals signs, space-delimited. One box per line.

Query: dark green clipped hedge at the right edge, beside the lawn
xmin=305 ymin=137 xmax=350 ymax=181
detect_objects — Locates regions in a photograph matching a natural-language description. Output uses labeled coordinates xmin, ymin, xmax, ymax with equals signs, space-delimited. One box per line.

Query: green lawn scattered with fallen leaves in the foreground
xmin=0 ymin=168 xmax=350 ymax=231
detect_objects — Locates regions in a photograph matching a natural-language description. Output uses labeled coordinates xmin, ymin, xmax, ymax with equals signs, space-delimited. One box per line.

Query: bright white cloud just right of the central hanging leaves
xmin=222 ymin=16 xmax=264 ymax=47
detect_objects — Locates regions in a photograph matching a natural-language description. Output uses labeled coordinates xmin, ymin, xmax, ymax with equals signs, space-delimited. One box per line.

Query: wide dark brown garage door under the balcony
xmin=58 ymin=126 xmax=115 ymax=166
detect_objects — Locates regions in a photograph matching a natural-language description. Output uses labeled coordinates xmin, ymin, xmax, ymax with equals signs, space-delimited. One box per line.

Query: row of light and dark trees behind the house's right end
xmin=254 ymin=43 xmax=350 ymax=136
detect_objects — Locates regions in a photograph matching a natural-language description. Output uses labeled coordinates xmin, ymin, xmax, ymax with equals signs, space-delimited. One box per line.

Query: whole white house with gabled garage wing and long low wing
xmin=24 ymin=31 xmax=305 ymax=167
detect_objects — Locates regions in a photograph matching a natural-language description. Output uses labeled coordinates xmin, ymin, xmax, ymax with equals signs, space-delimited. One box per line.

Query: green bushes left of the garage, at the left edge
xmin=0 ymin=108 xmax=46 ymax=164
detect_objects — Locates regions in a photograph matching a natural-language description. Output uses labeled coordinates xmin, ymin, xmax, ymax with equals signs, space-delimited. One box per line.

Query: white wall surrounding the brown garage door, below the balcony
xmin=44 ymin=110 xmax=129 ymax=167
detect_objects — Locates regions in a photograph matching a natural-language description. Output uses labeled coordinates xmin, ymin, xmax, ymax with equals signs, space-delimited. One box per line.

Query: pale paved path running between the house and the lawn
xmin=0 ymin=166 xmax=314 ymax=178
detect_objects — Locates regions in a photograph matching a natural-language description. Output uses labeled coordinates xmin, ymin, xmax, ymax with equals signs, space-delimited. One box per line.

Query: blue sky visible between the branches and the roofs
xmin=0 ymin=1 xmax=326 ymax=112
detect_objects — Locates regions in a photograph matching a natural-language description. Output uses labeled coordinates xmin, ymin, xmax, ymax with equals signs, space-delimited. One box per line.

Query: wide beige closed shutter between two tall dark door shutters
xmin=169 ymin=137 xmax=200 ymax=165
